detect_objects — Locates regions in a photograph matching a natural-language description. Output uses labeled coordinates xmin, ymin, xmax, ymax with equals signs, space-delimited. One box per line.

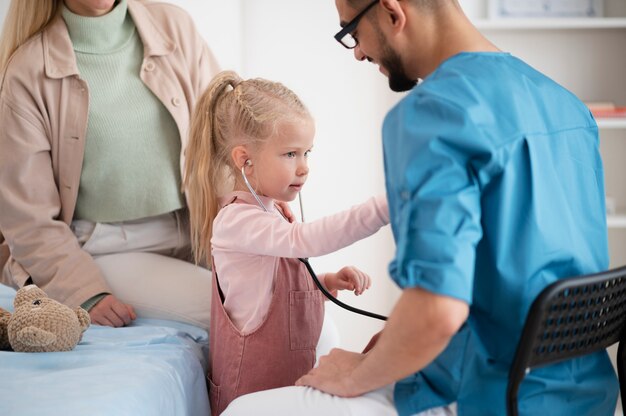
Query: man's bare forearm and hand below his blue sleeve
xmin=296 ymin=288 xmax=469 ymax=397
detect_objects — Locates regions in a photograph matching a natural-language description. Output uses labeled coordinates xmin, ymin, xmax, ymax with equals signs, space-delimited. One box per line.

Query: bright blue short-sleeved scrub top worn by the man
xmin=383 ymin=53 xmax=618 ymax=416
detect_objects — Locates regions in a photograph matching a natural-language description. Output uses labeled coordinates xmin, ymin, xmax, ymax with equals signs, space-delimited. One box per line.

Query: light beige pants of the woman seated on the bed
xmin=72 ymin=213 xmax=211 ymax=330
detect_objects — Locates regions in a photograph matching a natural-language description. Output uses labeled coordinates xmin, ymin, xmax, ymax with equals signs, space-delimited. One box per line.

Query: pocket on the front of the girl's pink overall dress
xmin=289 ymin=290 xmax=324 ymax=351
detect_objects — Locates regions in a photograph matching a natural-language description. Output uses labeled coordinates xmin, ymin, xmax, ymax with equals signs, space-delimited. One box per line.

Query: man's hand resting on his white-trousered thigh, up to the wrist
xmin=296 ymin=348 xmax=366 ymax=397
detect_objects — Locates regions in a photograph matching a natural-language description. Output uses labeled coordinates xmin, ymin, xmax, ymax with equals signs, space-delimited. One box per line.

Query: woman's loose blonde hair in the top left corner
xmin=0 ymin=0 xmax=63 ymax=71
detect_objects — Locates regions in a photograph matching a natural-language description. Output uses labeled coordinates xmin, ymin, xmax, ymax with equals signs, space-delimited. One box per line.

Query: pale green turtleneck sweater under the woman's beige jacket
xmin=62 ymin=0 xmax=184 ymax=222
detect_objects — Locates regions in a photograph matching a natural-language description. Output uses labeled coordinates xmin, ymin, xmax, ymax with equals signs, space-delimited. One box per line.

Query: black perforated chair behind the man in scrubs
xmin=506 ymin=266 xmax=626 ymax=416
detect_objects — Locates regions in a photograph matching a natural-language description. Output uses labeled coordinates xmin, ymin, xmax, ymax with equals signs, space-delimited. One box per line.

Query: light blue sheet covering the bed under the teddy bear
xmin=0 ymin=285 xmax=210 ymax=416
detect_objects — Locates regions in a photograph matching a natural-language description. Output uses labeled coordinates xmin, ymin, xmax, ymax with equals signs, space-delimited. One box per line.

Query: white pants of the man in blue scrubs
xmin=222 ymin=384 xmax=456 ymax=416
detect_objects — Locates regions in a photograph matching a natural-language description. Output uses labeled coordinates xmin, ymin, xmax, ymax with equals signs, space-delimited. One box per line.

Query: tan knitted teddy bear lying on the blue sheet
xmin=0 ymin=285 xmax=91 ymax=352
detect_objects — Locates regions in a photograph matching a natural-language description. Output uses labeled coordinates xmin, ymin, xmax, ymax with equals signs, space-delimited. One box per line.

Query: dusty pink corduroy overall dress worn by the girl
xmin=208 ymin=202 xmax=324 ymax=416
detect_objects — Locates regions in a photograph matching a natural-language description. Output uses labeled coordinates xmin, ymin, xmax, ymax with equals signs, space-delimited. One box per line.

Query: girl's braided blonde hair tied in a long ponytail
xmin=183 ymin=71 xmax=311 ymax=264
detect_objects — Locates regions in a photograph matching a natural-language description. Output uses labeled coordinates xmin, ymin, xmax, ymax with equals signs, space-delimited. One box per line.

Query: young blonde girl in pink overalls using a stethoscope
xmin=185 ymin=71 xmax=389 ymax=415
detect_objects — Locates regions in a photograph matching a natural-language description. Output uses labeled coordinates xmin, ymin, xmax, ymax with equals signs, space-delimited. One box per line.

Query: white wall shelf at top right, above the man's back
xmin=474 ymin=17 xmax=626 ymax=30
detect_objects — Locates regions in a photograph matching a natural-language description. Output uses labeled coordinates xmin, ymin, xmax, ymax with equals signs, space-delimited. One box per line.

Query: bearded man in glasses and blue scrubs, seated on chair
xmin=222 ymin=0 xmax=618 ymax=416
